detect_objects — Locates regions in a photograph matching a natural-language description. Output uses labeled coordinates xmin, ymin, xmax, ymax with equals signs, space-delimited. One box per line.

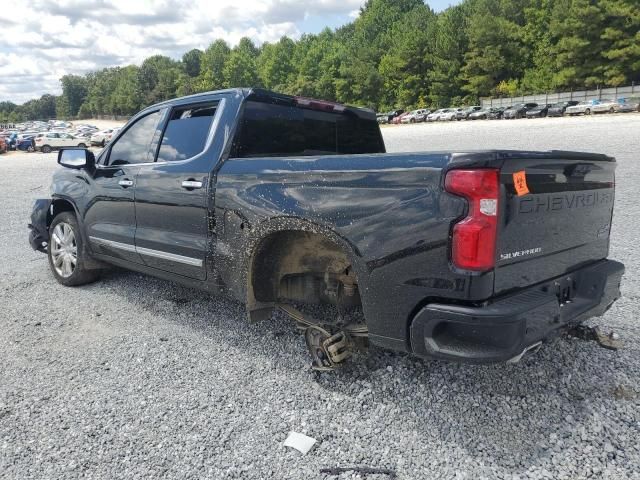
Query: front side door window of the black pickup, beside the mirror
xmin=109 ymin=111 xmax=162 ymax=165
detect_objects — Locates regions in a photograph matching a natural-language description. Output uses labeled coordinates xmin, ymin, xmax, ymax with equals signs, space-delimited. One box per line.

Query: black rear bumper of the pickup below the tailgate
xmin=410 ymin=260 xmax=624 ymax=363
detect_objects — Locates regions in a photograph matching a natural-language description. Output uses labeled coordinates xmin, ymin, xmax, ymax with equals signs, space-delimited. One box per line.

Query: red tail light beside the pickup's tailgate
xmin=444 ymin=169 xmax=500 ymax=271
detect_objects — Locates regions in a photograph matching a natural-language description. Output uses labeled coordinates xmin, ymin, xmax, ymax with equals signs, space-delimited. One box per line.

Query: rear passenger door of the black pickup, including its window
xmin=136 ymin=101 xmax=220 ymax=280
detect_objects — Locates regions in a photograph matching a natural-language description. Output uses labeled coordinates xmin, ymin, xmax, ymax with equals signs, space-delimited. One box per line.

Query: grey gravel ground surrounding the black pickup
xmin=0 ymin=114 xmax=640 ymax=480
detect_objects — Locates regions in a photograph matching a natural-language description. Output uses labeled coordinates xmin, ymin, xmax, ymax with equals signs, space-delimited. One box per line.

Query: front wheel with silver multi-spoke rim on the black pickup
xmin=47 ymin=212 xmax=100 ymax=287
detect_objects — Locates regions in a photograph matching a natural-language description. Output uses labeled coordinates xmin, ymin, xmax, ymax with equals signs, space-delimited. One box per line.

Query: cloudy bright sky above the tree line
xmin=0 ymin=0 xmax=460 ymax=103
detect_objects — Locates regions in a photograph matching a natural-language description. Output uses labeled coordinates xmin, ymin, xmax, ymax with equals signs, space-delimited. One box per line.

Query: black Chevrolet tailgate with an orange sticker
xmin=494 ymin=152 xmax=616 ymax=294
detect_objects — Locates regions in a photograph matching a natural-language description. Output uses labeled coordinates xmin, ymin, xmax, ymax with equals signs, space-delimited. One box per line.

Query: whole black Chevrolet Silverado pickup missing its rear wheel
xmin=29 ymin=89 xmax=624 ymax=368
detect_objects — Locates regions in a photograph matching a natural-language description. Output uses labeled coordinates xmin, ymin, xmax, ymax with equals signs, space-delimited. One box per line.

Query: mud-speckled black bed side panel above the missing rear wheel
xmin=216 ymin=154 xmax=484 ymax=349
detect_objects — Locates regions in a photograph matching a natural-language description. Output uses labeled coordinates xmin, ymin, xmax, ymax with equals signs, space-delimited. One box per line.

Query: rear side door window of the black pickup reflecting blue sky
xmin=158 ymin=103 xmax=218 ymax=162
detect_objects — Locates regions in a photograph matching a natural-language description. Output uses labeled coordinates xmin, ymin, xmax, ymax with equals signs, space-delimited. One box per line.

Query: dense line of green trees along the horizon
xmin=6 ymin=0 xmax=640 ymax=120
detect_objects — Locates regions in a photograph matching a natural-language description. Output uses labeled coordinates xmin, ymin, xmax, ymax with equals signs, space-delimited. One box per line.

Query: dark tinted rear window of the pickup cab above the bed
xmin=233 ymin=100 xmax=384 ymax=157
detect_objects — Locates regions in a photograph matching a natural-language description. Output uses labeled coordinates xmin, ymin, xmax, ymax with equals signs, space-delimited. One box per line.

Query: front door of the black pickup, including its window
xmin=84 ymin=110 xmax=163 ymax=263
